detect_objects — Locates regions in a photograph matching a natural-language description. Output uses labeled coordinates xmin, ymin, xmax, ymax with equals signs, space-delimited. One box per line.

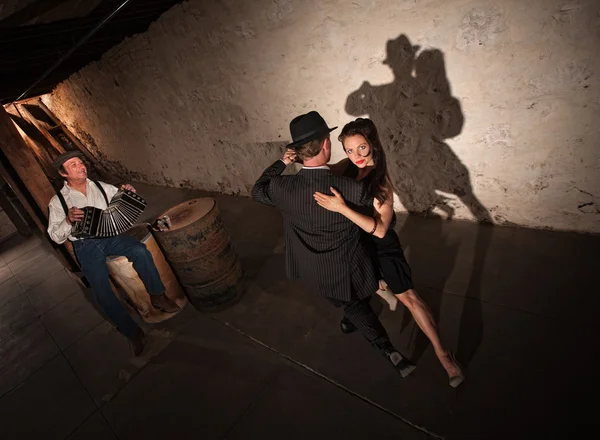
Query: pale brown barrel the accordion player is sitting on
xmin=106 ymin=225 xmax=188 ymax=323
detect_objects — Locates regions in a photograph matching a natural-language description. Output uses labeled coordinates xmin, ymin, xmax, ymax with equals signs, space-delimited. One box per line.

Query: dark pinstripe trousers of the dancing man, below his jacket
xmin=328 ymin=297 xmax=393 ymax=349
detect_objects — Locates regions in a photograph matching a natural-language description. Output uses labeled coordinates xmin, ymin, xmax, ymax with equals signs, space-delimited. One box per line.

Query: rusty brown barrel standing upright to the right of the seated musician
xmin=152 ymin=197 xmax=244 ymax=312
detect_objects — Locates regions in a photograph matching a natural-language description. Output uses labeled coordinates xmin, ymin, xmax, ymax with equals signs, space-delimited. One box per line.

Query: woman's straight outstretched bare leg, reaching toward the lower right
xmin=396 ymin=289 xmax=462 ymax=377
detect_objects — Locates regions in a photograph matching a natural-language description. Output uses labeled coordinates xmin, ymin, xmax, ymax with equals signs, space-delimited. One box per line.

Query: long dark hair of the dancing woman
xmin=338 ymin=118 xmax=392 ymax=204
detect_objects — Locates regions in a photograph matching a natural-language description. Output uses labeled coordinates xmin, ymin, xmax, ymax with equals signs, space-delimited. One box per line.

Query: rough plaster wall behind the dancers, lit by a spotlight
xmin=44 ymin=0 xmax=600 ymax=232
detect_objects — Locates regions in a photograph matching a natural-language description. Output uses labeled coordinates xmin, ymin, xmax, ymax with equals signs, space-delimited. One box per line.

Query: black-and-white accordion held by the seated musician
xmin=71 ymin=190 xmax=146 ymax=238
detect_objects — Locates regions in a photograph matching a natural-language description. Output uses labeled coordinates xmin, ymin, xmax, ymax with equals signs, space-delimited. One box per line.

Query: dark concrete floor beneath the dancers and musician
xmin=0 ymin=181 xmax=600 ymax=440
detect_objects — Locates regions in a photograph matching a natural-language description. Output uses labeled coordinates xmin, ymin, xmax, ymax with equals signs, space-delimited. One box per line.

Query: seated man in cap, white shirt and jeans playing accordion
xmin=48 ymin=151 xmax=179 ymax=356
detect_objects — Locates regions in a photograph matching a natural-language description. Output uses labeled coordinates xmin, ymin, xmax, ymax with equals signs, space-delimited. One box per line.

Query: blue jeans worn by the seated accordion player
xmin=73 ymin=235 xmax=165 ymax=337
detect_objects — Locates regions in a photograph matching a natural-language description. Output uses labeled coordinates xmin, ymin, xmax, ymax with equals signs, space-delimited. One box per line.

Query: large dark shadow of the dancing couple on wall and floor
xmin=345 ymin=35 xmax=493 ymax=365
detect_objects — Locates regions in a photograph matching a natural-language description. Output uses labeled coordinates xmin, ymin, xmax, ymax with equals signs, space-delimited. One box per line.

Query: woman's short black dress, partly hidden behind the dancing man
xmin=343 ymin=162 xmax=414 ymax=294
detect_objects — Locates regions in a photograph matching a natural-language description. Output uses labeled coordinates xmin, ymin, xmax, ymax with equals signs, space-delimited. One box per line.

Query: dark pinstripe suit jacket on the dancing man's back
xmin=252 ymin=160 xmax=378 ymax=301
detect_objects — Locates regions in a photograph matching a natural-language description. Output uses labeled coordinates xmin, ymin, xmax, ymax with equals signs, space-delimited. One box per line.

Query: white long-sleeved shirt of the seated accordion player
xmin=48 ymin=179 xmax=119 ymax=244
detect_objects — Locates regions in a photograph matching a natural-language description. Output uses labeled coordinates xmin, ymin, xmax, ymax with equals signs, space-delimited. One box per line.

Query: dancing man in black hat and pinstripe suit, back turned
xmin=252 ymin=111 xmax=415 ymax=377
